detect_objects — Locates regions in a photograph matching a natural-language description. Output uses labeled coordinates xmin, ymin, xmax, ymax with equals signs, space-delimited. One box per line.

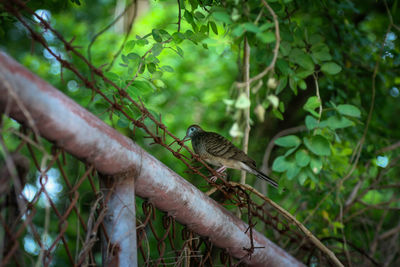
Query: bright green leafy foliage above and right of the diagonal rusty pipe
xmin=0 ymin=0 xmax=400 ymax=264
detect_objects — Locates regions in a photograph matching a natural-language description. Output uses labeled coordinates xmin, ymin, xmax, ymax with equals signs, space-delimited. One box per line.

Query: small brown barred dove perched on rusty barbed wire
xmin=183 ymin=124 xmax=278 ymax=188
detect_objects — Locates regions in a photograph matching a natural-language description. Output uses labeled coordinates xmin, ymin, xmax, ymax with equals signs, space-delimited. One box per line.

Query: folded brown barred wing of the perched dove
xmin=201 ymin=132 xmax=256 ymax=167
